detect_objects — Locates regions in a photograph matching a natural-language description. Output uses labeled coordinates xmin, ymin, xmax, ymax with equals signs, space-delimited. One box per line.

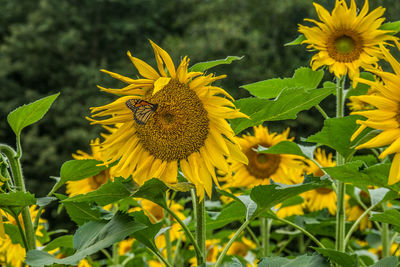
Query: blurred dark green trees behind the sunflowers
xmin=0 ymin=0 xmax=400 ymax=229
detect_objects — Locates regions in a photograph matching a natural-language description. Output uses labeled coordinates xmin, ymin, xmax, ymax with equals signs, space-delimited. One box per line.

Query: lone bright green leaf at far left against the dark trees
xmin=7 ymin=93 xmax=60 ymax=136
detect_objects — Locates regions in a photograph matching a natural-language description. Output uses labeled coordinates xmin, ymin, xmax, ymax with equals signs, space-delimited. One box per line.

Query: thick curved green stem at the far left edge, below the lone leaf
xmin=0 ymin=144 xmax=36 ymax=250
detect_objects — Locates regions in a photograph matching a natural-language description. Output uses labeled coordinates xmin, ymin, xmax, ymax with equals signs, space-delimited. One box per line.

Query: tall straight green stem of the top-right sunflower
xmin=336 ymin=76 xmax=346 ymax=255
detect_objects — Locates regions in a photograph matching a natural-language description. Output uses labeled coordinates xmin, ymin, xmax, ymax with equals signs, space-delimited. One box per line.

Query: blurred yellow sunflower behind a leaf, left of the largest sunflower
xmin=66 ymin=138 xmax=112 ymax=197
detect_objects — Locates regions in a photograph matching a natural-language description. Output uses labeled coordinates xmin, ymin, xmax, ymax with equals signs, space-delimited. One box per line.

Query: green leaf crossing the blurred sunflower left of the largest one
xmin=60 ymin=159 xmax=108 ymax=183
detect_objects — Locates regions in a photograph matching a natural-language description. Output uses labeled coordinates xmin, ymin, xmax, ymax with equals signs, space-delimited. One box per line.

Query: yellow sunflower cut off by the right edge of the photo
xmin=351 ymin=42 xmax=400 ymax=184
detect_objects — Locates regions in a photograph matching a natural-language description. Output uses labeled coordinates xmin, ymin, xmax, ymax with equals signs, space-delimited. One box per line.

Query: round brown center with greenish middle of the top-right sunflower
xmin=327 ymin=30 xmax=363 ymax=63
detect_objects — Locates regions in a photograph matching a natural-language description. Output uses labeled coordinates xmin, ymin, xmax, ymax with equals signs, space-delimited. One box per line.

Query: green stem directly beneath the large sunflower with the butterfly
xmin=194 ymin=195 xmax=206 ymax=266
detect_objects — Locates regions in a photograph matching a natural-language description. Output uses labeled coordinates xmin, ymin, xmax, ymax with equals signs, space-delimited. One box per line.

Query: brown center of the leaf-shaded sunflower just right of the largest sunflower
xmin=245 ymin=144 xmax=281 ymax=179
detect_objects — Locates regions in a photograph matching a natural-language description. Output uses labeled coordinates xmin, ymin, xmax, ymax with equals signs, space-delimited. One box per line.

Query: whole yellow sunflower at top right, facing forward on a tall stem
xmin=299 ymin=0 xmax=396 ymax=82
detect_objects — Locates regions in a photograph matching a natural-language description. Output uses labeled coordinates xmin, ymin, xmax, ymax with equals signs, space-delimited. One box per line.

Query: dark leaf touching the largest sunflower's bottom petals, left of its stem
xmin=133 ymin=178 xmax=168 ymax=207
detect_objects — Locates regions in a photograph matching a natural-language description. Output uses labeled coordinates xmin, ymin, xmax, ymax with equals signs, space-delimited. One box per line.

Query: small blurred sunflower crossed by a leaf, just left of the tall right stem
xmin=303 ymin=148 xmax=337 ymax=215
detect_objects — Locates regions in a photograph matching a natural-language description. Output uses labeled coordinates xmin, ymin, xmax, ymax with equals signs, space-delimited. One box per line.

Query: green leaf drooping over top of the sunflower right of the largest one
xmin=258 ymin=141 xmax=315 ymax=158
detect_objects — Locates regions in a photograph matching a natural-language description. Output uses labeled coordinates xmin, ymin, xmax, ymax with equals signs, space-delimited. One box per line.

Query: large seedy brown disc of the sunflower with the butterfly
xmin=136 ymin=79 xmax=209 ymax=161
